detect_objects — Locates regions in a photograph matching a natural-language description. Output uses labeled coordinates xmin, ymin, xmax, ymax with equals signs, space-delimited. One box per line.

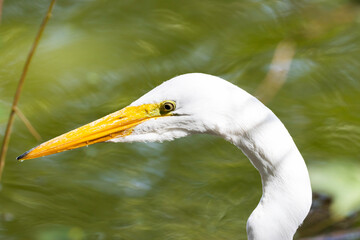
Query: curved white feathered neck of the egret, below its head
xmin=218 ymin=93 xmax=312 ymax=240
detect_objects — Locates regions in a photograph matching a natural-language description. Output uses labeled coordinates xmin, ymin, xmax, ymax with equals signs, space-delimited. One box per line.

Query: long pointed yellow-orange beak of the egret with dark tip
xmin=17 ymin=104 xmax=163 ymax=160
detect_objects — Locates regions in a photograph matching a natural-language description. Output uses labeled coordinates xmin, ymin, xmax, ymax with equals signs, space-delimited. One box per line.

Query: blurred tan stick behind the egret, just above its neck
xmin=255 ymin=41 xmax=295 ymax=103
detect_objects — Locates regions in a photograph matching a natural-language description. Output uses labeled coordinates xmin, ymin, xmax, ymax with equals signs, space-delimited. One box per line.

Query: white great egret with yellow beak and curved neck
xmin=17 ymin=73 xmax=312 ymax=240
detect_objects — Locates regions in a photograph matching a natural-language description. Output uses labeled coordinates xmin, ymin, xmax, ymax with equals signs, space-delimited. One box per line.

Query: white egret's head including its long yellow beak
xmin=17 ymin=73 xmax=242 ymax=160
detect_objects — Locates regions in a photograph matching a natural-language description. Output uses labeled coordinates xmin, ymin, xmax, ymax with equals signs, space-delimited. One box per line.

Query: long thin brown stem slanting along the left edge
xmin=0 ymin=0 xmax=56 ymax=180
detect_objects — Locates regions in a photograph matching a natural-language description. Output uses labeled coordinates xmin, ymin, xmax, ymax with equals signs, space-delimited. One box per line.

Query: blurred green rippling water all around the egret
xmin=0 ymin=0 xmax=360 ymax=240
